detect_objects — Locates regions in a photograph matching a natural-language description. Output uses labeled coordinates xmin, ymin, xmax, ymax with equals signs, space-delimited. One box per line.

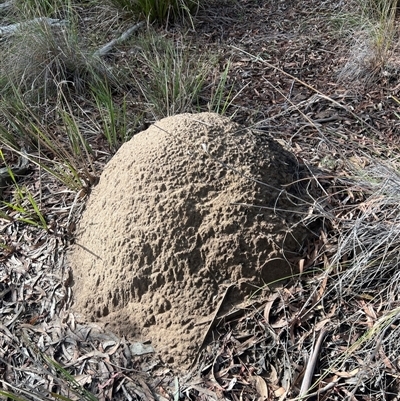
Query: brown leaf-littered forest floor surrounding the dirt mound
xmin=0 ymin=0 xmax=400 ymax=400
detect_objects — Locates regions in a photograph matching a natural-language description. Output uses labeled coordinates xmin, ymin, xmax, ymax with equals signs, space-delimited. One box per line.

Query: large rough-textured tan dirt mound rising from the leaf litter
xmin=70 ymin=113 xmax=312 ymax=368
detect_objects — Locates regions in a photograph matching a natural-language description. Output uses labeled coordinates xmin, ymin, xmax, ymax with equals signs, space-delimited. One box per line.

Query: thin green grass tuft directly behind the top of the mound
xmin=121 ymin=29 xmax=239 ymax=120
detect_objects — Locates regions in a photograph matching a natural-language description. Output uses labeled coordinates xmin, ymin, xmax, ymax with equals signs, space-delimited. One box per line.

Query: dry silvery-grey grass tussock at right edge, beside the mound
xmin=326 ymin=161 xmax=400 ymax=301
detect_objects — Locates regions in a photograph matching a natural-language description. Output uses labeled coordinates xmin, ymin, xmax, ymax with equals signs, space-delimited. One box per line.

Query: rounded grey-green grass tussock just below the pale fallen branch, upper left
xmin=0 ymin=21 xmax=111 ymax=103
